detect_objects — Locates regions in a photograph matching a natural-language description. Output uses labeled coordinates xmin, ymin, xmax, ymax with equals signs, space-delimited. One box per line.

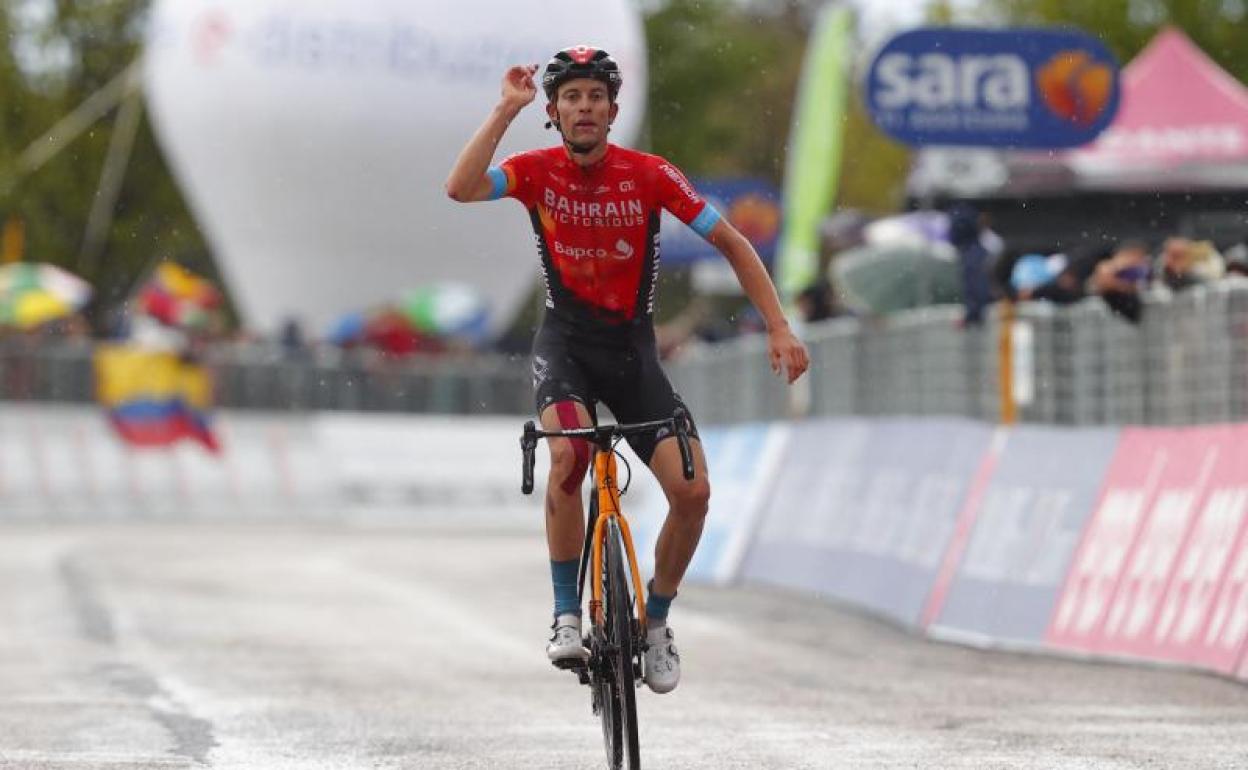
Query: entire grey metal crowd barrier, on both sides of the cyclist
xmin=0 ymin=281 xmax=1248 ymax=426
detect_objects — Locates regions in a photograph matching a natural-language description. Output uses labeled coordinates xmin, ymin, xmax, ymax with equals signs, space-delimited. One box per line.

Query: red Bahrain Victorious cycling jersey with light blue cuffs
xmin=489 ymin=145 xmax=719 ymax=327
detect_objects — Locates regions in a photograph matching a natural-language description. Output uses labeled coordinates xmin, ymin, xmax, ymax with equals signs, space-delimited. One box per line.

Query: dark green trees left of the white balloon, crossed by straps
xmin=0 ymin=0 xmax=216 ymax=318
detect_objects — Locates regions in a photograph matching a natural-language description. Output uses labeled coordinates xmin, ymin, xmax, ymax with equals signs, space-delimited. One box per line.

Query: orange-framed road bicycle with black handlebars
xmin=520 ymin=409 xmax=694 ymax=770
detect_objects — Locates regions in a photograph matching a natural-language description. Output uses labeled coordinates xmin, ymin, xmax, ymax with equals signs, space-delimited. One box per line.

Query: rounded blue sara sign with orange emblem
xmin=865 ymin=27 xmax=1119 ymax=147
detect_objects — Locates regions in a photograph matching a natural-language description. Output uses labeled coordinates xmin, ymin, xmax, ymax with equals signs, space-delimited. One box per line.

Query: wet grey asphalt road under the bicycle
xmin=0 ymin=522 xmax=1248 ymax=770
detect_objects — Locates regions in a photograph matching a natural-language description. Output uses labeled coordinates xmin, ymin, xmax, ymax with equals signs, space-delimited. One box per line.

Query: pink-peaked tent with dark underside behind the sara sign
xmin=907 ymin=27 xmax=1248 ymax=246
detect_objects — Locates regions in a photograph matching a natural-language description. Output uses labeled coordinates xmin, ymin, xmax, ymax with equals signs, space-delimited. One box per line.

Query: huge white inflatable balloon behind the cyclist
xmin=144 ymin=0 xmax=646 ymax=331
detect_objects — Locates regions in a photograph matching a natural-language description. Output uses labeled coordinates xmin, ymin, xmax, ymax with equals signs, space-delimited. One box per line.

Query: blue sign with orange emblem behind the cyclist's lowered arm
xmin=661 ymin=177 xmax=780 ymax=265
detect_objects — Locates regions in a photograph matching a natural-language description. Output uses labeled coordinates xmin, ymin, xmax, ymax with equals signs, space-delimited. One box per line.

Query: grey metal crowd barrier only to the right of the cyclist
xmin=669 ymin=280 xmax=1248 ymax=426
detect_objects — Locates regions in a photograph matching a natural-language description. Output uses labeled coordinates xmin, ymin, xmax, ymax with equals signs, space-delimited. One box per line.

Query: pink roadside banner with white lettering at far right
xmin=1047 ymin=426 xmax=1248 ymax=674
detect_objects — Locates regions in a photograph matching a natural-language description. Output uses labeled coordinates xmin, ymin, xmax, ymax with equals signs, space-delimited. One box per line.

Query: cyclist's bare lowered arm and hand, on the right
xmin=706 ymin=220 xmax=810 ymax=383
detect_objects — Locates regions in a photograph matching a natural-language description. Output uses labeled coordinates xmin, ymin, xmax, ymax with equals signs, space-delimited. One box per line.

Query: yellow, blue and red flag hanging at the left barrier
xmin=95 ymin=344 xmax=221 ymax=453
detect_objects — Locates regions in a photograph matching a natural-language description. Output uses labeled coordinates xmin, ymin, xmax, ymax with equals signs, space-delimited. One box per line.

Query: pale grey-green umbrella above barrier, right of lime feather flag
xmin=831 ymin=245 xmax=961 ymax=314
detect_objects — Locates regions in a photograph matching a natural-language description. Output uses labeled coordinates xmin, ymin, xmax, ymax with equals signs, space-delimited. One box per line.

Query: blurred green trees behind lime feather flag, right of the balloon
xmin=645 ymin=0 xmax=910 ymax=212
